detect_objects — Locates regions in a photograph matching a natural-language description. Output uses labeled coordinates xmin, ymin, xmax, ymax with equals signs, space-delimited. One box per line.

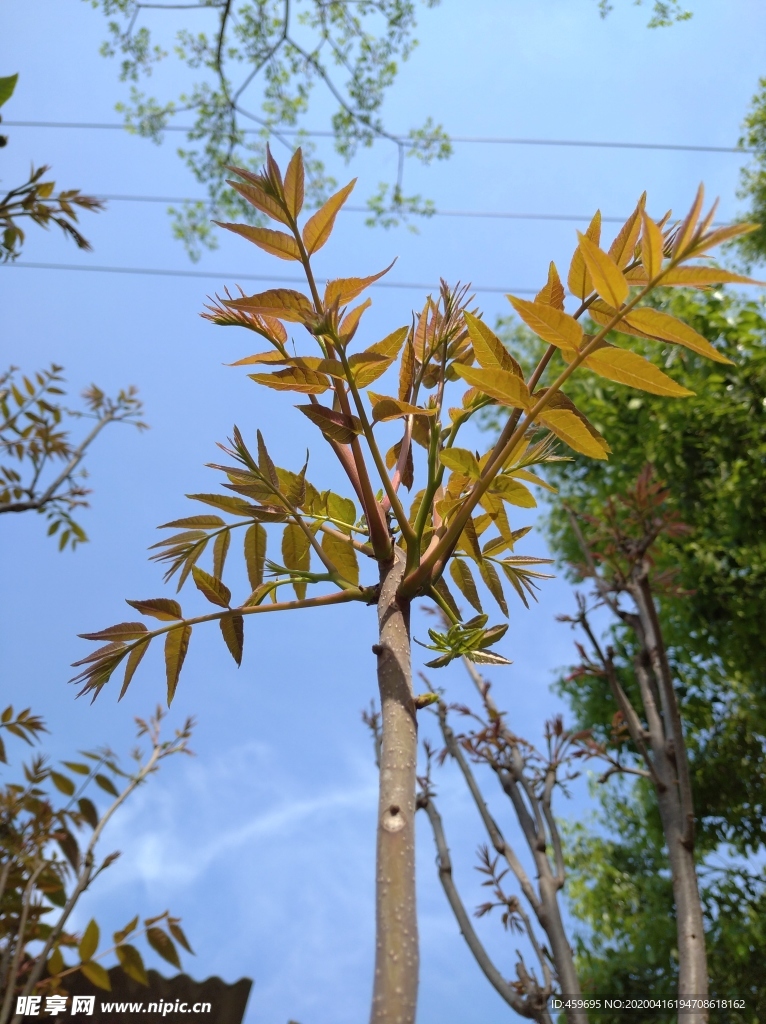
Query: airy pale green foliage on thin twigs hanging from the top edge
xmin=89 ymin=0 xmax=452 ymax=259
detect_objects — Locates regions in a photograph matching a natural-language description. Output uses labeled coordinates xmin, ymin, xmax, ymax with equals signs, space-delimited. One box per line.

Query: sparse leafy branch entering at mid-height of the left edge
xmin=0 ymin=365 xmax=145 ymax=551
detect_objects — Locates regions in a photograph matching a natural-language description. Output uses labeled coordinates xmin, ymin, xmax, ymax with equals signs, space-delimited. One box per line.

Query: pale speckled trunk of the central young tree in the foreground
xmin=370 ymin=548 xmax=420 ymax=1024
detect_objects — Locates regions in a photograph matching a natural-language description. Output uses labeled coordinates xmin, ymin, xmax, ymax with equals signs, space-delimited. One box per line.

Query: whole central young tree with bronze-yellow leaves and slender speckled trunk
xmin=77 ymin=151 xmax=748 ymax=1024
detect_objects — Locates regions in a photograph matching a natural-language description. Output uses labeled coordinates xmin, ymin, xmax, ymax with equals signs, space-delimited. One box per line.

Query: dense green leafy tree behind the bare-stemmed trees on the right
xmin=487 ymin=290 xmax=766 ymax=1021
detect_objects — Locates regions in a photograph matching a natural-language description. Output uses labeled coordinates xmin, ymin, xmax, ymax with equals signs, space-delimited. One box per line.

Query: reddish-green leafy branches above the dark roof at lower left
xmin=0 ymin=707 xmax=192 ymax=1024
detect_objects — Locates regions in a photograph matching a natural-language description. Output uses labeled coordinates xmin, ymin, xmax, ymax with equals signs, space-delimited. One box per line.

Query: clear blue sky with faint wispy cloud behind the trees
xmin=0 ymin=0 xmax=766 ymax=1024
